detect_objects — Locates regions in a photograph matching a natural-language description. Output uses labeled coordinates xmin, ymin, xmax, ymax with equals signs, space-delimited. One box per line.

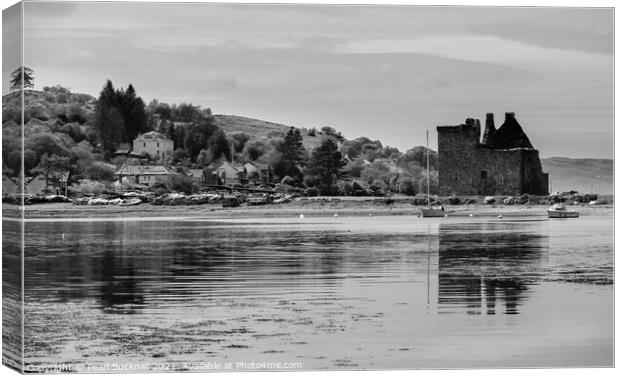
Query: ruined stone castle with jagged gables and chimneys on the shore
xmin=437 ymin=112 xmax=549 ymax=195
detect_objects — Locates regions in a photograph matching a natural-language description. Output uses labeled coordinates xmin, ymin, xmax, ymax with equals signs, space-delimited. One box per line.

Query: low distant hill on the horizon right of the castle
xmin=541 ymin=157 xmax=614 ymax=194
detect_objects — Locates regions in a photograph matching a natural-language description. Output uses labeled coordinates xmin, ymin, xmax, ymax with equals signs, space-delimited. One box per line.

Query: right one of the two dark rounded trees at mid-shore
xmin=306 ymin=138 xmax=346 ymax=195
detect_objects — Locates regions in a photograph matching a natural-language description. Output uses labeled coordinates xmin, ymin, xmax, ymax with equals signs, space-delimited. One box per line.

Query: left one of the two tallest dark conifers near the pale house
xmin=95 ymin=80 xmax=126 ymax=160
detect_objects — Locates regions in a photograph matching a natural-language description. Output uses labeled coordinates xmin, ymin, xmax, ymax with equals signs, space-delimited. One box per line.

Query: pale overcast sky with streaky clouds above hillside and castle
xmin=3 ymin=2 xmax=613 ymax=158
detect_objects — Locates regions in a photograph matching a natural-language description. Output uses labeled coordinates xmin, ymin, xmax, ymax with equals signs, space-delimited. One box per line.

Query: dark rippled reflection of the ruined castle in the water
xmin=438 ymin=222 xmax=548 ymax=315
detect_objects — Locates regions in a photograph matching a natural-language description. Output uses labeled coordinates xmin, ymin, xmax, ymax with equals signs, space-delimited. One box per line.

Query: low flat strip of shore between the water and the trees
xmin=3 ymin=197 xmax=614 ymax=219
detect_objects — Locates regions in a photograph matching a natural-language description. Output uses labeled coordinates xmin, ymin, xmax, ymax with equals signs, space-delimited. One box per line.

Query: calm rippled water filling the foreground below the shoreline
xmin=20 ymin=212 xmax=613 ymax=371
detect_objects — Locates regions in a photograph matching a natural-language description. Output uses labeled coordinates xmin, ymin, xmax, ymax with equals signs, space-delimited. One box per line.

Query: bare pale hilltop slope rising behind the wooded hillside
xmin=215 ymin=115 xmax=321 ymax=150
